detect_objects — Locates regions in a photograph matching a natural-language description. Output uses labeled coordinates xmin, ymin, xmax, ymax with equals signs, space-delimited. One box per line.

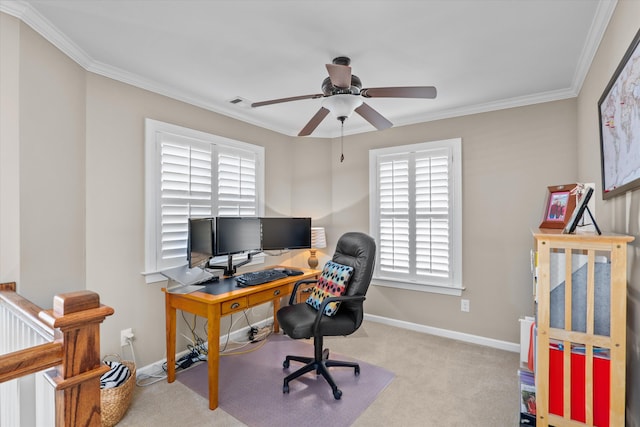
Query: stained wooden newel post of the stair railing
xmin=39 ymin=291 xmax=114 ymax=426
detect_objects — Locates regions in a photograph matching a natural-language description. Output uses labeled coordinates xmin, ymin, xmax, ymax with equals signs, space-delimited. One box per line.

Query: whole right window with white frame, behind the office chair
xmin=369 ymin=138 xmax=462 ymax=295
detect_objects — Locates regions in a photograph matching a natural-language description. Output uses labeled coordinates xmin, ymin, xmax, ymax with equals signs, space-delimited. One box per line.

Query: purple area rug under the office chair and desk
xmin=177 ymin=335 xmax=394 ymax=427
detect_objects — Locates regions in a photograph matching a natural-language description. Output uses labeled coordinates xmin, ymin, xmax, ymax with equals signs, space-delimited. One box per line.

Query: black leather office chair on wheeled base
xmin=277 ymin=232 xmax=376 ymax=400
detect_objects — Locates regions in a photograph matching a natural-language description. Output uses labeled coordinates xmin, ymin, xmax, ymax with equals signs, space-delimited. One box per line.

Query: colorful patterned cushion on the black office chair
xmin=306 ymin=261 xmax=353 ymax=316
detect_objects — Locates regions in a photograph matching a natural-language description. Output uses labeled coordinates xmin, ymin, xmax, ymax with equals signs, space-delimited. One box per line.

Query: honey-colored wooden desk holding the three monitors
xmin=162 ymin=267 xmax=320 ymax=409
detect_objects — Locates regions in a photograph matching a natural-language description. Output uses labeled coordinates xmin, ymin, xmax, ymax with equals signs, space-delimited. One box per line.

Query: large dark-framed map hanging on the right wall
xmin=598 ymin=30 xmax=640 ymax=200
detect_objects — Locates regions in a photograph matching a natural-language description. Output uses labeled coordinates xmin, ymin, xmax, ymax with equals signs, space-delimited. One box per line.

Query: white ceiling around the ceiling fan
xmin=0 ymin=0 xmax=616 ymax=137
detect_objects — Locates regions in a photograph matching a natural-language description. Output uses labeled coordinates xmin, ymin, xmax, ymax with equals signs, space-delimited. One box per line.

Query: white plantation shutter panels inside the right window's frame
xmin=372 ymin=144 xmax=453 ymax=286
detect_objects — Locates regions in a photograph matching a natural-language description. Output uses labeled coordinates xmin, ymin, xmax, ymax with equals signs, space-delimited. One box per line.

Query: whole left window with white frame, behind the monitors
xmin=145 ymin=119 xmax=264 ymax=283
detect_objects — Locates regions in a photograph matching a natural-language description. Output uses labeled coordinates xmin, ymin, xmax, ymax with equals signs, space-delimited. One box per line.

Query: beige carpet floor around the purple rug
xmin=118 ymin=322 xmax=519 ymax=427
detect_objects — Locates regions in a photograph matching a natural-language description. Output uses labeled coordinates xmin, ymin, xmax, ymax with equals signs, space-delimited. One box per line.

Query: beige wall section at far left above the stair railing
xmin=0 ymin=15 xmax=86 ymax=306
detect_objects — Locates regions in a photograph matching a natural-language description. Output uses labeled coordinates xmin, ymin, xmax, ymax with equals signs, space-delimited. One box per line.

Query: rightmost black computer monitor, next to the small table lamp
xmin=261 ymin=218 xmax=311 ymax=251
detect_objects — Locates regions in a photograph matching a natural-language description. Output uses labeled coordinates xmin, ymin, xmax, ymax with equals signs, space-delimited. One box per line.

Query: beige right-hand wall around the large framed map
xmin=578 ymin=0 xmax=640 ymax=427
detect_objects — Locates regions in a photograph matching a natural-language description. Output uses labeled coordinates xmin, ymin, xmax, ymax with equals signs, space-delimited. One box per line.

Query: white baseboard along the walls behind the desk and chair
xmin=137 ymin=313 xmax=520 ymax=375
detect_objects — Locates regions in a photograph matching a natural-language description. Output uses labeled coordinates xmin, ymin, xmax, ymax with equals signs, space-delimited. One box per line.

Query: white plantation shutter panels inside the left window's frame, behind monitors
xmin=158 ymin=134 xmax=258 ymax=269
